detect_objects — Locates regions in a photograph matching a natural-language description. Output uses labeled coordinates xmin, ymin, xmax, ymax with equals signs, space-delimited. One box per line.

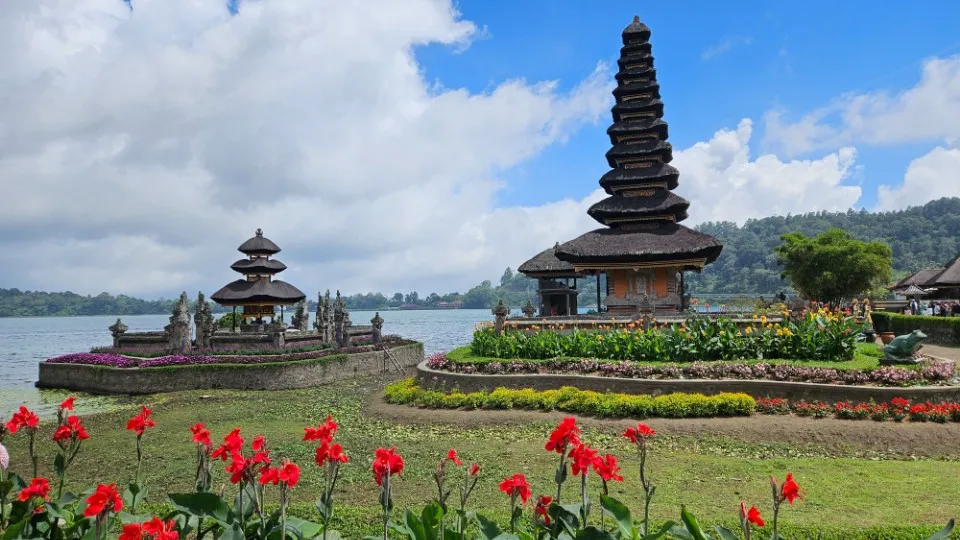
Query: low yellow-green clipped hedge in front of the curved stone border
xmin=386 ymin=378 xmax=756 ymax=418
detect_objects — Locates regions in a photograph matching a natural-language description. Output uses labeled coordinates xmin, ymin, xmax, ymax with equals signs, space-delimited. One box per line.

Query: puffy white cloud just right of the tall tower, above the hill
xmin=673 ymin=119 xmax=861 ymax=224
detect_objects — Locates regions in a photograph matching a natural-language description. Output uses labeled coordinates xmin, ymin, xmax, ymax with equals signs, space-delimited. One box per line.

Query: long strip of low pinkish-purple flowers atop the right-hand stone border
xmin=427 ymin=353 xmax=956 ymax=386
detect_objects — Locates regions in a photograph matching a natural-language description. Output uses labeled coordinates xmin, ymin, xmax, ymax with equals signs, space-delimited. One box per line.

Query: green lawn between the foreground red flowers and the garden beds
xmin=5 ymin=378 xmax=960 ymax=538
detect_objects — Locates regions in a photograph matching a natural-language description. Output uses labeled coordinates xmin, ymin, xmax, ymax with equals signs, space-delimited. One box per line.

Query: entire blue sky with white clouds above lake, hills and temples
xmin=0 ymin=0 xmax=960 ymax=298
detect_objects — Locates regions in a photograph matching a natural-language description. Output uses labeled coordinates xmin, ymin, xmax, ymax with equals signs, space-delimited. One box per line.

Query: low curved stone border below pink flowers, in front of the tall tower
xmin=417 ymin=361 xmax=960 ymax=403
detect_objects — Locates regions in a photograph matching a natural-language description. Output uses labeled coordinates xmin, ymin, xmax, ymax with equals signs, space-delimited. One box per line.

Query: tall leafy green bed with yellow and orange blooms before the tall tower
xmin=470 ymin=311 xmax=861 ymax=362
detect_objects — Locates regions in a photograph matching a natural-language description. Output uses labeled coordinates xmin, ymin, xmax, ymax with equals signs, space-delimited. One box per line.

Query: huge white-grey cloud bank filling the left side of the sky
xmin=0 ymin=0 xmax=611 ymax=294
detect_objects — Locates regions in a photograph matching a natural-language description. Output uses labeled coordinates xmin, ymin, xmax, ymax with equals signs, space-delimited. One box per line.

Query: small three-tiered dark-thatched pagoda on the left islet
xmin=210 ymin=229 xmax=306 ymax=321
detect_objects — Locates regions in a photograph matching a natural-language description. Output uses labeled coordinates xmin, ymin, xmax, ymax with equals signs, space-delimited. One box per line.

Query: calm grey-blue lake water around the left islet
xmin=0 ymin=309 xmax=502 ymax=419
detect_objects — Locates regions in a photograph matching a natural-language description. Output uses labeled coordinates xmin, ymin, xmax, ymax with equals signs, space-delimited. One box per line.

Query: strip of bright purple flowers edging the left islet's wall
xmin=46 ymin=338 xmax=414 ymax=368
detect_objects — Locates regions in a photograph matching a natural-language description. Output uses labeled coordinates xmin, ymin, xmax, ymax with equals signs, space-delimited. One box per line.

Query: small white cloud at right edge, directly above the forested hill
xmin=877 ymin=146 xmax=960 ymax=210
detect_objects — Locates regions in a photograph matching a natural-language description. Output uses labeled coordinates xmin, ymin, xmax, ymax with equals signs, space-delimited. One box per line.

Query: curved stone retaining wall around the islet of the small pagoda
xmin=36 ymin=343 xmax=424 ymax=394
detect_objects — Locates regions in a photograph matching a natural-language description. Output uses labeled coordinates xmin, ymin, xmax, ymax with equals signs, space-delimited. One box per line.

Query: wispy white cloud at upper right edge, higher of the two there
xmin=764 ymin=56 xmax=960 ymax=156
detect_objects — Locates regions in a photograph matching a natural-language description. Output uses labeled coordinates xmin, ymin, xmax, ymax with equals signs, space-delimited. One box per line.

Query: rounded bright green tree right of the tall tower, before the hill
xmin=774 ymin=229 xmax=893 ymax=302
